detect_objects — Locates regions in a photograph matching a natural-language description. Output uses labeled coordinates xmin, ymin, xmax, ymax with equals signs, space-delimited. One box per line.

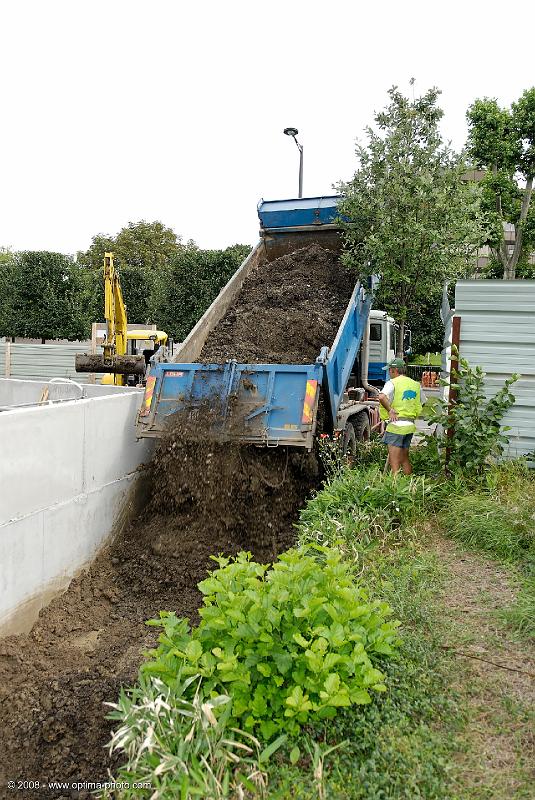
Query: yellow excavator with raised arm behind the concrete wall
xmin=75 ymin=253 xmax=168 ymax=386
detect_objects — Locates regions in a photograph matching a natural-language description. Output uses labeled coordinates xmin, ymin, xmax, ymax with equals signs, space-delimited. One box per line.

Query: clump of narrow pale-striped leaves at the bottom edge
xmin=103 ymin=675 xmax=286 ymax=800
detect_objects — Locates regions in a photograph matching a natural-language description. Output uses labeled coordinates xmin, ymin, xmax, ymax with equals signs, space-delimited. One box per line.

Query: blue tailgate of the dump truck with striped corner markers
xmin=137 ymin=361 xmax=323 ymax=450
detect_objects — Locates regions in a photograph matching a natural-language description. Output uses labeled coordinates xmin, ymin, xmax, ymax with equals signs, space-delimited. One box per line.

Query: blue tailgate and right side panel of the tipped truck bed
xmin=137 ymin=284 xmax=371 ymax=450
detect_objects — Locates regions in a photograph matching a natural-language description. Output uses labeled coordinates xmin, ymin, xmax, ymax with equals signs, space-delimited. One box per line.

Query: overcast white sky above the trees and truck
xmin=0 ymin=0 xmax=535 ymax=253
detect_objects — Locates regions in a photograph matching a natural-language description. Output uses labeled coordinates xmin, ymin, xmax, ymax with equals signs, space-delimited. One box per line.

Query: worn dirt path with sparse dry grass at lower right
xmin=435 ymin=539 xmax=535 ymax=800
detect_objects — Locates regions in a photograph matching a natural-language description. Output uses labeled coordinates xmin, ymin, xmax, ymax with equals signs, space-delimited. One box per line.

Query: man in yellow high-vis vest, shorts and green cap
xmin=379 ymin=358 xmax=427 ymax=475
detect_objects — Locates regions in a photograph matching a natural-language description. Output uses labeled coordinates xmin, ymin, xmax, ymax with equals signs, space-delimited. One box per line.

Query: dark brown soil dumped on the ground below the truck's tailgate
xmin=0 ymin=416 xmax=317 ymax=798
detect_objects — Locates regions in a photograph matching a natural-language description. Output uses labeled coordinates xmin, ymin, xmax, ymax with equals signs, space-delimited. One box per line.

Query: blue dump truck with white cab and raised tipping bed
xmin=137 ymin=196 xmax=402 ymax=451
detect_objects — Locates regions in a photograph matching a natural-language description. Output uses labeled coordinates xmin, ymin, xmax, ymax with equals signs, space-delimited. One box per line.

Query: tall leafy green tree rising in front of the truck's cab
xmin=340 ymin=81 xmax=485 ymax=355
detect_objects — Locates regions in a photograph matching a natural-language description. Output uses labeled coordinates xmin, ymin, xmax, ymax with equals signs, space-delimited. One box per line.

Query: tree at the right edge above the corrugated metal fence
xmin=467 ymin=87 xmax=535 ymax=280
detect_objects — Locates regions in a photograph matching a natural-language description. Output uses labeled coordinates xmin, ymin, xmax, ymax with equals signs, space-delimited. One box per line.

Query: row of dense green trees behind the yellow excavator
xmin=0 ymin=220 xmax=250 ymax=341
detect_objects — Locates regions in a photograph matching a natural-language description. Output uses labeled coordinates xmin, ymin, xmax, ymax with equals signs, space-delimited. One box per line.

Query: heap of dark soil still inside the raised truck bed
xmin=200 ymin=245 xmax=355 ymax=364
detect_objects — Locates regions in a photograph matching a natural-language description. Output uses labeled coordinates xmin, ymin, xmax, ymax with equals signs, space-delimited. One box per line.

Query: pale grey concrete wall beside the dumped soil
xmin=0 ymin=387 xmax=153 ymax=634
